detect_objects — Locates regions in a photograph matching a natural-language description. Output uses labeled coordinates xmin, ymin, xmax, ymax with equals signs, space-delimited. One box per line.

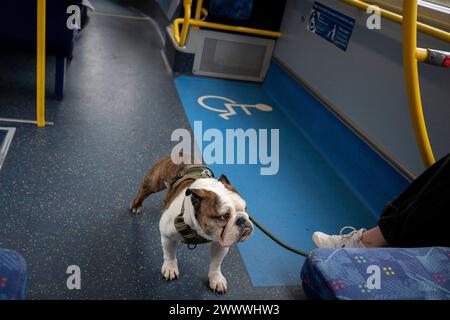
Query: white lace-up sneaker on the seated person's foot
xmin=312 ymin=227 xmax=366 ymax=248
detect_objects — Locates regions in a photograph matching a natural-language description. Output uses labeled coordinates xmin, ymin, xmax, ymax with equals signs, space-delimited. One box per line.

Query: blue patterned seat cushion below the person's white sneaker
xmin=301 ymin=247 xmax=450 ymax=300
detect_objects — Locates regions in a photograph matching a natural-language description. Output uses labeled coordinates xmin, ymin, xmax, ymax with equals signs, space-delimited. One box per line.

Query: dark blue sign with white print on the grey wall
xmin=308 ymin=1 xmax=355 ymax=51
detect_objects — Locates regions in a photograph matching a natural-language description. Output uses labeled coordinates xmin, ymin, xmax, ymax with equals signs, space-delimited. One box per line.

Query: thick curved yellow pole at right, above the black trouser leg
xmin=403 ymin=0 xmax=436 ymax=167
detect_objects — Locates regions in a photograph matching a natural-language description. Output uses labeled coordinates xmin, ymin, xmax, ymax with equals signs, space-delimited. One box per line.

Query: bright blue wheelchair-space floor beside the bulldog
xmin=175 ymin=76 xmax=378 ymax=286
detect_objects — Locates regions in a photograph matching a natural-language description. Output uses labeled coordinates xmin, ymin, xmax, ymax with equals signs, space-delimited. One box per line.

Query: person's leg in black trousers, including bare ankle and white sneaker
xmin=313 ymin=155 xmax=450 ymax=248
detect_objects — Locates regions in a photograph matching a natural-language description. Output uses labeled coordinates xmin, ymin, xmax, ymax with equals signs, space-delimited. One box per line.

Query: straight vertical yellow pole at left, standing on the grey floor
xmin=36 ymin=0 xmax=47 ymax=127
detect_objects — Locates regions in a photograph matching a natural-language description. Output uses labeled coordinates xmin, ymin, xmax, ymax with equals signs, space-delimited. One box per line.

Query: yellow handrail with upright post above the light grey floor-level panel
xmin=173 ymin=0 xmax=281 ymax=47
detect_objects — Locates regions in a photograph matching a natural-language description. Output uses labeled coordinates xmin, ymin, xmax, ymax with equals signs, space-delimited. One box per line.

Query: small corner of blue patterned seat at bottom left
xmin=0 ymin=249 xmax=28 ymax=300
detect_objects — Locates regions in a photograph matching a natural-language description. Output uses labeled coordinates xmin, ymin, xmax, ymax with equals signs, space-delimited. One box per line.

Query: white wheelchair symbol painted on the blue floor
xmin=197 ymin=96 xmax=273 ymax=120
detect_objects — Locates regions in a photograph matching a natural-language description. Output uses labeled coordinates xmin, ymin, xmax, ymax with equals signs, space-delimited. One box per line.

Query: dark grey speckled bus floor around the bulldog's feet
xmin=0 ymin=1 xmax=303 ymax=299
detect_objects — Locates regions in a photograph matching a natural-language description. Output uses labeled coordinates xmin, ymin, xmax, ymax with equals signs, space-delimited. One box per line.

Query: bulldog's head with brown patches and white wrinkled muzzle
xmin=186 ymin=175 xmax=253 ymax=247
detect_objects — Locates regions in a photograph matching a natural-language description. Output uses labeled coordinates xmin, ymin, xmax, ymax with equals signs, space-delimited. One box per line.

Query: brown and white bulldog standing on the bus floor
xmin=130 ymin=157 xmax=253 ymax=293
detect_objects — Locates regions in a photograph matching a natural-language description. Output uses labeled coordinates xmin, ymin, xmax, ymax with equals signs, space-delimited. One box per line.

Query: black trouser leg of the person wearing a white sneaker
xmin=378 ymin=154 xmax=450 ymax=247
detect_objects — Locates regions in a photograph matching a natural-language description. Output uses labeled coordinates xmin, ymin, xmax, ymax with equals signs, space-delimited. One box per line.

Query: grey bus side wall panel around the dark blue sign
xmin=274 ymin=0 xmax=450 ymax=174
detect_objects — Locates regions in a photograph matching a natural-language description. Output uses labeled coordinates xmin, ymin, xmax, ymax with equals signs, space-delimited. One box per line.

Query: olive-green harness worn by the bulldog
xmin=164 ymin=164 xmax=214 ymax=249
